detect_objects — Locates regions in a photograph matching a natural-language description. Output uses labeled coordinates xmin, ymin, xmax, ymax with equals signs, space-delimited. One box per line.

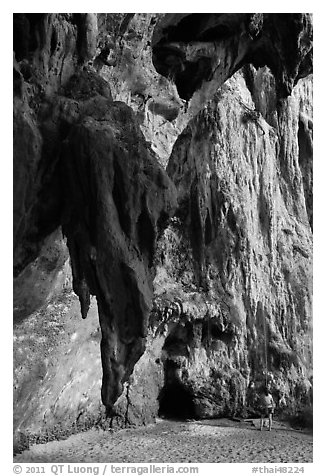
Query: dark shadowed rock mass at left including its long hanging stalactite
xmin=14 ymin=15 xmax=175 ymax=416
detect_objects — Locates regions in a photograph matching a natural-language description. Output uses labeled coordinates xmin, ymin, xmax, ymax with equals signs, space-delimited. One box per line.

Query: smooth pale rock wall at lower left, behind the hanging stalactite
xmin=13 ymin=288 xmax=104 ymax=451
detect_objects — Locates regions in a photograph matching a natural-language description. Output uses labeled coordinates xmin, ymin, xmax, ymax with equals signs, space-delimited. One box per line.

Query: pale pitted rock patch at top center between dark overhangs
xmin=94 ymin=13 xmax=188 ymax=166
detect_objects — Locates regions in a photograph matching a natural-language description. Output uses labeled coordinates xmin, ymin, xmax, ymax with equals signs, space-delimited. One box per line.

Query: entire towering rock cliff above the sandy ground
xmin=14 ymin=14 xmax=312 ymax=448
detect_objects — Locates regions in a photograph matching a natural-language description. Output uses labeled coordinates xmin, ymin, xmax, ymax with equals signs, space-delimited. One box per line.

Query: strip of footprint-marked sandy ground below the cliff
xmin=14 ymin=420 xmax=313 ymax=463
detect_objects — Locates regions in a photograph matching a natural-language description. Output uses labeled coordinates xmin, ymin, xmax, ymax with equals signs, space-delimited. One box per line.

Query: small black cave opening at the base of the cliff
xmin=158 ymin=360 xmax=195 ymax=420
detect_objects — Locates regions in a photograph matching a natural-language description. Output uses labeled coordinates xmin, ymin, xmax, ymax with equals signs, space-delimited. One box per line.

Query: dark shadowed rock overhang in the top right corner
xmin=153 ymin=13 xmax=312 ymax=99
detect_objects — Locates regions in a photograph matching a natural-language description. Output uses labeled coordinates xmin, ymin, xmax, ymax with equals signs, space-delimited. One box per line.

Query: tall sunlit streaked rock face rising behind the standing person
xmin=155 ymin=68 xmax=312 ymax=417
